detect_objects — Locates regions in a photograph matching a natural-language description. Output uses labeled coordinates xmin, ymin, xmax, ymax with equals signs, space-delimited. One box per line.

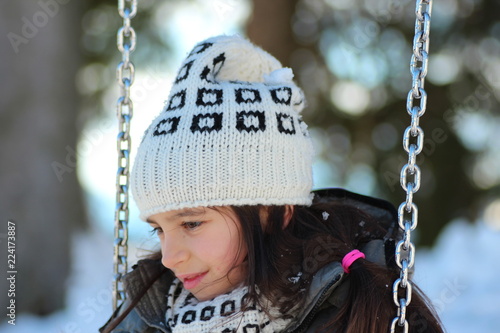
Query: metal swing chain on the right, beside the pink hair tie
xmin=390 ymin=0 xmax=432 ymax=333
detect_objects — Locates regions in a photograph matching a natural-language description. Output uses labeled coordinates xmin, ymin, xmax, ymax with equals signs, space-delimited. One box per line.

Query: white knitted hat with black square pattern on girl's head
xmin=131 ymin=36 xmax=313 ymax=220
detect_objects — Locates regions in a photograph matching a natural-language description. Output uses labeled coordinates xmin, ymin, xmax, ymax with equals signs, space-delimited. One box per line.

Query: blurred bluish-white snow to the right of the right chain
xmin=415 ymin=221 xmax=500 ymax=333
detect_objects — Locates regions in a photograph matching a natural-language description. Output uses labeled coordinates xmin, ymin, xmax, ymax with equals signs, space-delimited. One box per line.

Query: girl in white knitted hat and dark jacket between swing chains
xmin=101 ymin=36 xmax=443 ymax=333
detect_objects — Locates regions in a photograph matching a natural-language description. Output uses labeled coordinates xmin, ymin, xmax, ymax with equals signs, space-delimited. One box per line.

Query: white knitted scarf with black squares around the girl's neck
xmin=166 ymin=279 xmax=291 ymax=333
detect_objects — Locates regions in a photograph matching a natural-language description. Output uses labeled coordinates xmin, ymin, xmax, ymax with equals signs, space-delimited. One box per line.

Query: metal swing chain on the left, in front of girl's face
xmin=113 ymin=0 xmax=137 ymax=310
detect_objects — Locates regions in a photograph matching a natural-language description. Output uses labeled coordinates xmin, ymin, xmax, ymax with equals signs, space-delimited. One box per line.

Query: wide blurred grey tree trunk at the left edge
xmin=0 ymin=1 xmax=86 ymax=320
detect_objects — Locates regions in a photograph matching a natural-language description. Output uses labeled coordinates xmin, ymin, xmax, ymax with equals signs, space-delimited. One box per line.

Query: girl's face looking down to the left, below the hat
xmin=148 ymin=207 xmax=247 ymax=301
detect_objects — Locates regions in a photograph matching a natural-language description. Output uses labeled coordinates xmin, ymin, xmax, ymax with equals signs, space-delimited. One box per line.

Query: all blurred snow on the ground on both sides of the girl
xmin=0 ymin=221 xmax=500 ymax=333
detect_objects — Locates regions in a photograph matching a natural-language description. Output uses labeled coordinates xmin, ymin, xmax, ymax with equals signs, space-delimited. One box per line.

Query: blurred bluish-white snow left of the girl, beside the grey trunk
xmin=0 ymin=230 xmax=150 ymax=333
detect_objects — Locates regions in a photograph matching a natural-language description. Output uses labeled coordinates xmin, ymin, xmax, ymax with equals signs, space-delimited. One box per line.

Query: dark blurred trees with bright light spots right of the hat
xmin=247 ymin=0 xmax=500 ymax=245
